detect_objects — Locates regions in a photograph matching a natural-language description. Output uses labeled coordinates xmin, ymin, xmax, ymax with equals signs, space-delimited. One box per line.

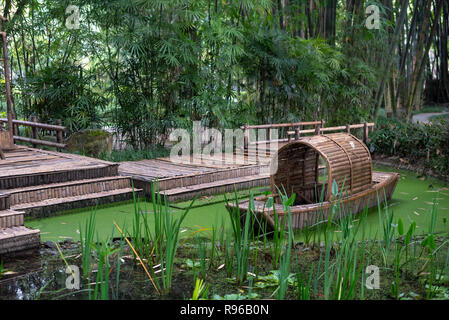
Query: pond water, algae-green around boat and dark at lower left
xmin=0 ymin=168 xmax=449 ymax=300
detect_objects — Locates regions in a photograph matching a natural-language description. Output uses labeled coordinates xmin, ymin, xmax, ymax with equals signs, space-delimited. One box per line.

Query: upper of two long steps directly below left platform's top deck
xmin=3 ymin=177 xmax=135 ymax=207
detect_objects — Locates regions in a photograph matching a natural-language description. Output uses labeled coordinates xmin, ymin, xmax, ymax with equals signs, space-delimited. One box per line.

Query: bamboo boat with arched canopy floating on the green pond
xmin=227 ymin=133 xmax=399 ymax=229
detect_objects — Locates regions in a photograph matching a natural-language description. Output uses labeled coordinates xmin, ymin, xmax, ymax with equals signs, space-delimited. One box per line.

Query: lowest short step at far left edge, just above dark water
xmin=0 ymin=226 xmax=41 ymax=255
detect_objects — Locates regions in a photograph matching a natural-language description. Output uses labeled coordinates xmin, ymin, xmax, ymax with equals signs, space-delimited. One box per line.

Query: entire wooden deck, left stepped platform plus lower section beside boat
xmin=0 ymin=146 xmax=269 ymax=255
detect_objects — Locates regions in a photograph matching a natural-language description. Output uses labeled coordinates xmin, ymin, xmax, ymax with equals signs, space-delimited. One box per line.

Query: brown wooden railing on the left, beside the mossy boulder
xmin=0 ymin=117 xmax=67 ymax=149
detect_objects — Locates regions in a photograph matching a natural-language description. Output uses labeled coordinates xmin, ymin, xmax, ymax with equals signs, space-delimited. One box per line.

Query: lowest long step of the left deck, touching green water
xmin=11 ymin=188 xmax=143 ymax=218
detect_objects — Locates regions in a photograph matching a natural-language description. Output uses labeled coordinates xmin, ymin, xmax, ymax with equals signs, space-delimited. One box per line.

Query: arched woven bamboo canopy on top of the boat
xmin=271 ymin=133 xmax=372 ymax=204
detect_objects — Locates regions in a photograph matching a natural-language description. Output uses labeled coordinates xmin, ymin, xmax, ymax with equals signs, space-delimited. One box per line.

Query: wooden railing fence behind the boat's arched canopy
xmin=240 ymin=120 xmax=374 ymax=150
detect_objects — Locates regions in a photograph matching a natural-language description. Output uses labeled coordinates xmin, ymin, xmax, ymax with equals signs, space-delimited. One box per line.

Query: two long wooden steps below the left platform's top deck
xmin=7 ymin=177 xmax=142 ymax=218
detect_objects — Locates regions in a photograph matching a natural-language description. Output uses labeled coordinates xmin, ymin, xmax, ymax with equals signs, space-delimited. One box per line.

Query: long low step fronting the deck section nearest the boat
xmin=159 ymin=173 xmax=270 ymax=202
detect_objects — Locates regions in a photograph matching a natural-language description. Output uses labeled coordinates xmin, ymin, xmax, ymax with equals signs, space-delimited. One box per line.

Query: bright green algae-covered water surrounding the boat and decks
xmin=25 ymin=167 xmax=449 ymax=241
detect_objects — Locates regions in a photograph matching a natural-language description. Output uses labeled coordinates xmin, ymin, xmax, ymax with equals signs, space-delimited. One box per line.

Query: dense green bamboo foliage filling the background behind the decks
xmin=10 ymin=0 xmax=383 ymax=144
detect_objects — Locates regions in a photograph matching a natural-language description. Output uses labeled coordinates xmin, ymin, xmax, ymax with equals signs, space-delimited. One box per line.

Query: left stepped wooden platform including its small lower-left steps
xmin=0 ymin=146 xmax=142 ymax=255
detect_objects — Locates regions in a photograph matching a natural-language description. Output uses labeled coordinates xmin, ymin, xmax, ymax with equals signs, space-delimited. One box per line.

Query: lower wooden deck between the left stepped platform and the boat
xmin=119 ymin=155 xmax=269 ymax=202
